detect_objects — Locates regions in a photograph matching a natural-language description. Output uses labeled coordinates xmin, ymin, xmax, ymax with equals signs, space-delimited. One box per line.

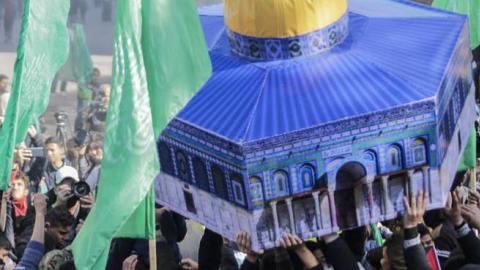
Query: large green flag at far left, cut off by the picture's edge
xmin=0 ymin=0 xmax=70 ymax=190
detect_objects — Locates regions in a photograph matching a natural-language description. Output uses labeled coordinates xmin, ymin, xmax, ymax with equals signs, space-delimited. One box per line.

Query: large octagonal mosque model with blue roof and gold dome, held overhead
xmin=156 ymin=0 xmax=475 ymax=249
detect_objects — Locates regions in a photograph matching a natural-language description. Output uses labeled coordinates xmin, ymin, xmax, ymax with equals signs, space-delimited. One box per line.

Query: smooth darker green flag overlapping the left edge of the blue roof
xmin=142 ymin=0 xmax=212 ymax=137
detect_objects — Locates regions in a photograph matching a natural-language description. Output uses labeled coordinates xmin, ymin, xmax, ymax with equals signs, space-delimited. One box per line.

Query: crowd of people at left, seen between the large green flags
xmin=0 ymin=64 xmax=110 ymax=269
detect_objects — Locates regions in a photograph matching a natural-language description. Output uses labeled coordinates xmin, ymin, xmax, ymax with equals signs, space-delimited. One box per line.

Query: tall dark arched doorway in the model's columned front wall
xmin=334 ymin=162 xmax=367 ymax=229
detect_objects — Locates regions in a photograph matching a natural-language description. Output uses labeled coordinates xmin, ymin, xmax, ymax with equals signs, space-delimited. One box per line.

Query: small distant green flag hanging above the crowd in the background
xmin=58 ymin=23 xmax=93 ymax=84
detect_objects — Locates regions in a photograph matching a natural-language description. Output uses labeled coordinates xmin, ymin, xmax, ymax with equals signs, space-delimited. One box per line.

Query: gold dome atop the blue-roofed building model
xmin=225 ymin=0 xmax=348 ymax=38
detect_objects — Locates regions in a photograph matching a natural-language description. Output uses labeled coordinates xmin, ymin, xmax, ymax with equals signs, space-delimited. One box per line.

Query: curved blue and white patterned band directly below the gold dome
xmin=228 ymin=13 xmax=348 ymax=61
